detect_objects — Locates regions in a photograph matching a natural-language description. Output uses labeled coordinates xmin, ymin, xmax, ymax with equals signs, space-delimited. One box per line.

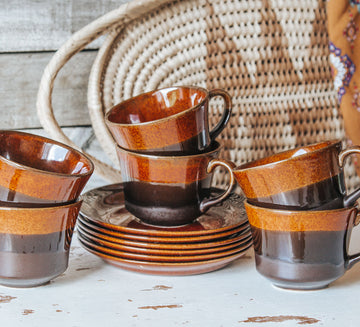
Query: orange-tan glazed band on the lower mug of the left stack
xmin=0 ymin=201 xmax=81 ymax=235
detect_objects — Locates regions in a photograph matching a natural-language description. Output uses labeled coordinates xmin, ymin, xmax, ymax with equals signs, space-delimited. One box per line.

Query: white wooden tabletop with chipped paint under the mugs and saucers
xmin=0 ymin=180 xmax=360 ymax=327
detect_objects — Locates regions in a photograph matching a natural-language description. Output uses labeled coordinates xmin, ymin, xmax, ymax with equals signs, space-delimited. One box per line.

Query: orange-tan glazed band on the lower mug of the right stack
xmin=245 ymin=202 xmax=358 ymax=232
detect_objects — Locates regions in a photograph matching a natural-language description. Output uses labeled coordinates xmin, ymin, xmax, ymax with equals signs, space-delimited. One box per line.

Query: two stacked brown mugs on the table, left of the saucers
xmin=0 ymin=130 xmax=94 ymax=287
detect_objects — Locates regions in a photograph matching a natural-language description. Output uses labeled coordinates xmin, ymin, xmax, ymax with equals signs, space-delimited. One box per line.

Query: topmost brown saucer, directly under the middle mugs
xmin=80 ymin=183 xmax=248 ymax=237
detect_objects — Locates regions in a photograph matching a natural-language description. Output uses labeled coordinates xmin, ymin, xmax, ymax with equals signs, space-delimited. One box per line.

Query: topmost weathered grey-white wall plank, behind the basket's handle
xmin=0 ymin=0 xmax=129 ymax=52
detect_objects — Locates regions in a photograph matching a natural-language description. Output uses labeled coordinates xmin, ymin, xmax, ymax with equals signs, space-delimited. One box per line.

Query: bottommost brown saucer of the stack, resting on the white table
xmin=79 ymin=240 xmax=252 ymax=276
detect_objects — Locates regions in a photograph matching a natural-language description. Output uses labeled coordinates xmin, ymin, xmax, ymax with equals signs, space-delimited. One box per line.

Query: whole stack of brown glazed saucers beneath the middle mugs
xmin=77 ymin=184 xmax=252 ymax=275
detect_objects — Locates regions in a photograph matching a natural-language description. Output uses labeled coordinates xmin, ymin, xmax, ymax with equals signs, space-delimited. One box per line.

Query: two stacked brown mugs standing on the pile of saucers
xmin=105 ymin=86 xmax=235 ymax=226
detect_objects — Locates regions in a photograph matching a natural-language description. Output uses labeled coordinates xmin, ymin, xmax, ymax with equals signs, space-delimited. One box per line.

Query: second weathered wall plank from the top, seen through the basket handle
xmin=0 ymin=51 xmax=97 ymax=129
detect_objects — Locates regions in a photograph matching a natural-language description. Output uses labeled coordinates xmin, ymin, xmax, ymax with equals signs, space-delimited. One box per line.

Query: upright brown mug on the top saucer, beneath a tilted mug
xmin=117 ymin=142 xmax=236 ymax=226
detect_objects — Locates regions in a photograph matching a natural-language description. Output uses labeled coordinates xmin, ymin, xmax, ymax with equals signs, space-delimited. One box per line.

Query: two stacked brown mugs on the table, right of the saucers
xmin=233 ymin=140 xmax=360 ymax=289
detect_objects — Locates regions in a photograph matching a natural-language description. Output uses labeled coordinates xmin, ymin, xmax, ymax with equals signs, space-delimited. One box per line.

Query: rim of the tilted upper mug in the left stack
xmin=0 ymin=130 xmax=95 ymax=178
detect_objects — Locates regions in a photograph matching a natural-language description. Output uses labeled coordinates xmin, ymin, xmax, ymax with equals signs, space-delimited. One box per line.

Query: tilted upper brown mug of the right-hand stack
xmin=233 ymin=140 xmax=360 ymax=210
